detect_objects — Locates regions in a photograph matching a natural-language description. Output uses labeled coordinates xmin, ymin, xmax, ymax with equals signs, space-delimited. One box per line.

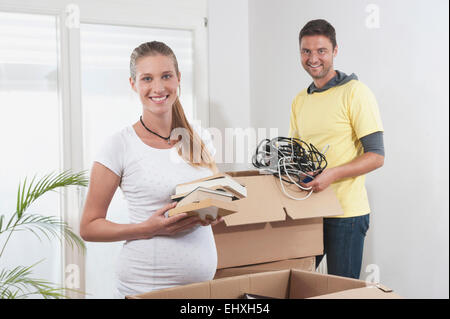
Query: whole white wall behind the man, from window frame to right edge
xmin=209 ymin=0 xmax=449 ymax=298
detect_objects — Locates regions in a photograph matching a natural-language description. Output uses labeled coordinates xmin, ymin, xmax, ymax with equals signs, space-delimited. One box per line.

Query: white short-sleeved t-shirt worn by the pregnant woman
xmin=95 ymin=126 xmax=217 ymax=298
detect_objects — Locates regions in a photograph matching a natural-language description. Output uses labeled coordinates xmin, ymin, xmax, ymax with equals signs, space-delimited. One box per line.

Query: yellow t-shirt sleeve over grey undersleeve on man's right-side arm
xmin=349 ymin=81 xmax=384 ymax=139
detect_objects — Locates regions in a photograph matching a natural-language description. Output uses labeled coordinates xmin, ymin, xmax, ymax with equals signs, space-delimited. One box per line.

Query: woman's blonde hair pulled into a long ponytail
xmin=130 ymin=41 xmax=218 ymax=172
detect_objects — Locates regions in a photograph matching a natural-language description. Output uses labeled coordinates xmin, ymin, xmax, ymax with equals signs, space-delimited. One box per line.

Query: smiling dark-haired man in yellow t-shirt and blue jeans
xmin=289 ymin=19 xmax=384 ymax=278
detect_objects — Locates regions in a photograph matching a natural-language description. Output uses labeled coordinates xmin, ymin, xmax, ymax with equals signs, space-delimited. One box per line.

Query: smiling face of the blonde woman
xmin=130 ymin=55 xmax=180 ymax=115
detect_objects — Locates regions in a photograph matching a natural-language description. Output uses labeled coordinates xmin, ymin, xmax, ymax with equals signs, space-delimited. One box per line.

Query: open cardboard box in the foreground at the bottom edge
xmin=126 ymin=269 xmax=401 ymax=299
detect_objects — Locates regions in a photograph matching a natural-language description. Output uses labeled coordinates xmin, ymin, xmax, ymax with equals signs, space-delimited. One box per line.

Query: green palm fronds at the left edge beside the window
xmin=0 ymin=171 xmax=88 ymax=299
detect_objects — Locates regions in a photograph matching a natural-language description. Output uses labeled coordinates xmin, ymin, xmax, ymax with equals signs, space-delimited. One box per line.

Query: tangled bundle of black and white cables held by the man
xmin=252 ymin=136 xmax=327 ymax=190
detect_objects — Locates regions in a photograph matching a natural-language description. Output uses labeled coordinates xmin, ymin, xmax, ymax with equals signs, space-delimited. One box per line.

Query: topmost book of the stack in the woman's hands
xmin=175 ymin=173 xmax=247 ymax=199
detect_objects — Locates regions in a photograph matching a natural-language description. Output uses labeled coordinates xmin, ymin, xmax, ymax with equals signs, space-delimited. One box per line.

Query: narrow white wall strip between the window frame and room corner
xmin=208 ymin=0 xmax=255 ymax=171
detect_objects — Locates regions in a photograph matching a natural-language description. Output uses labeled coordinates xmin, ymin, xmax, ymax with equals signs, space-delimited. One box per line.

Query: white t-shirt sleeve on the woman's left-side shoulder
xmin=94 ymin=133 xmax=125 ymax=177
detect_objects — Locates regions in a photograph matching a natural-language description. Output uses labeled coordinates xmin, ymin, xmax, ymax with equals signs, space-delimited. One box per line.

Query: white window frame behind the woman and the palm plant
xmin=0 ymin=0 xmax=209 ymax=298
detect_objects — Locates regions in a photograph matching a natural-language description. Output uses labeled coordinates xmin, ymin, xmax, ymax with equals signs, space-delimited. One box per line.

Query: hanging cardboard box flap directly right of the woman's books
xmin=224 ymin=175 xmax=286 ymax=226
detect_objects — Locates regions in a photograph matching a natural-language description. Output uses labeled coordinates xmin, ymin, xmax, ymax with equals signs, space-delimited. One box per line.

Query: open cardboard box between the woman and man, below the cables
xmin=213 ymin=170 xmax=342 ymax=269
